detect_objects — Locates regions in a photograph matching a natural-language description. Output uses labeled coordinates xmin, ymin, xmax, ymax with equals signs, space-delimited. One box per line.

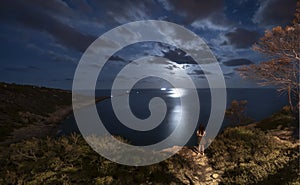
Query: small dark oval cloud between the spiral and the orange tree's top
xmin=223 ymin=28 xmax=260 ymax=48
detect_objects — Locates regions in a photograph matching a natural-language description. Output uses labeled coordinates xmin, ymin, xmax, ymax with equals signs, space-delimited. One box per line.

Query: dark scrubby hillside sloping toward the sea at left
xmin=0 ymin=83 xmax=71 ymax=141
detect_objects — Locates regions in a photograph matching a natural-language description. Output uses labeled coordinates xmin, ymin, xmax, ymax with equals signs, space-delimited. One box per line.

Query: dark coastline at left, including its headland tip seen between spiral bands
xmin=0 ymin=82 xmax=110 ymax=145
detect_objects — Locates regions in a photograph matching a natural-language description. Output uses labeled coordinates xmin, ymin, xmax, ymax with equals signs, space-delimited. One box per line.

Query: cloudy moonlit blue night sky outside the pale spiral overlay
xmin=0 ymin=0 xmax=296 ymax=89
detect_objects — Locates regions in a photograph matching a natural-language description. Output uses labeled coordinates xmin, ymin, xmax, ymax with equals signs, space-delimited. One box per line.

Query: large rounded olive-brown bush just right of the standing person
xmin=207 ymin=127 xmax=299 ymax=184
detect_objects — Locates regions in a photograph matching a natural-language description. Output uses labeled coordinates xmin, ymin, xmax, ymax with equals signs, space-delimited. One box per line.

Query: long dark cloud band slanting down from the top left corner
xmin=0 ymin=0 xmax=96 ymax=52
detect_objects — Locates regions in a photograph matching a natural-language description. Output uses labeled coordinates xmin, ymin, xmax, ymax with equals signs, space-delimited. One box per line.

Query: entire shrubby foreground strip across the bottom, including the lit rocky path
xmin=0 ymin=120 xmax=300 ymax=185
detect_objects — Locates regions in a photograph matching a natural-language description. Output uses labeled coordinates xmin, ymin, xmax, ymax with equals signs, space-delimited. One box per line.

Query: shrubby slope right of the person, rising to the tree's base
xmin=207 ymin=109 xmax=300 ymax=185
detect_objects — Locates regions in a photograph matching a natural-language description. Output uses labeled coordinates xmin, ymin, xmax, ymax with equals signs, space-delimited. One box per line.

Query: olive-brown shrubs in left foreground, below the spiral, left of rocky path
xmin=0 ymin=134 xmax=180 ymax=184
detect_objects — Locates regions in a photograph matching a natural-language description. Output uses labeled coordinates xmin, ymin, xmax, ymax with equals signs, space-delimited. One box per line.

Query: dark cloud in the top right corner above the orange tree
xmin=253 ymin=0 xmax=297 ymax=26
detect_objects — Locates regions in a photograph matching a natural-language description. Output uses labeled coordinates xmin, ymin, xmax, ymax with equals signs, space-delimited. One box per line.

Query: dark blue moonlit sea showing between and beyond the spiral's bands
xmin=58 ymin=88 xmax=287 ymax=145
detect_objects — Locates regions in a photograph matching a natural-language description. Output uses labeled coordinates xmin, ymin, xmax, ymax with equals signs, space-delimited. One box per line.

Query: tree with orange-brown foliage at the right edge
xmin=238 ymin=0 xmax=300 ymax=112
